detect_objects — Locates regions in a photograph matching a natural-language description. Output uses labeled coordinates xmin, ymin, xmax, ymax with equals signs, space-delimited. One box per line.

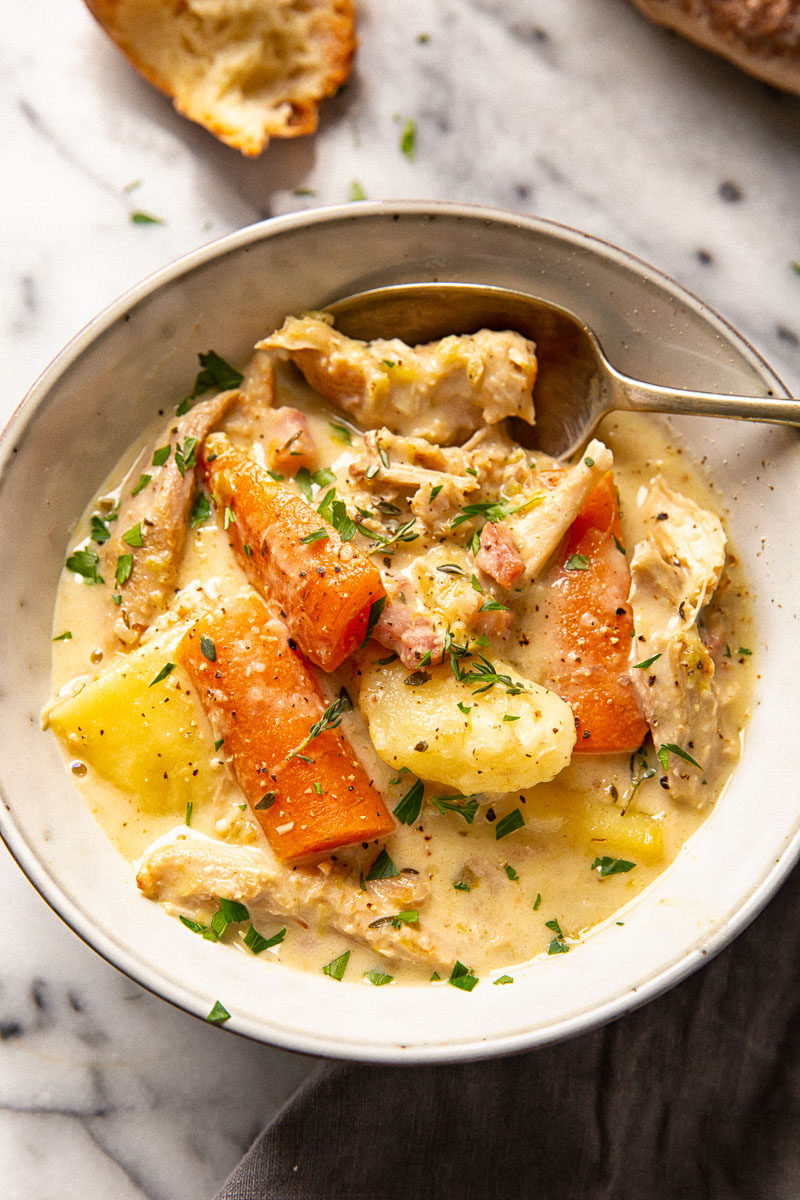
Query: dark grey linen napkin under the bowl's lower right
xmin=217 ymin=863 xmax=800 ymax=1200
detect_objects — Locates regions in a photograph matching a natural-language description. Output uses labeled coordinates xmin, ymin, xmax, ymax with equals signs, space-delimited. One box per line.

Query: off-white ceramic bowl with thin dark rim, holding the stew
xmin=0 ymin=203 xmax=800 ymax=1062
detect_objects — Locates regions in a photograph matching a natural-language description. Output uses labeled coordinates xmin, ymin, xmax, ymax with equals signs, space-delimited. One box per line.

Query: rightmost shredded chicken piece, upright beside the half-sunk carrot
xmin=630 ymin=480 xmax=734 ymax=808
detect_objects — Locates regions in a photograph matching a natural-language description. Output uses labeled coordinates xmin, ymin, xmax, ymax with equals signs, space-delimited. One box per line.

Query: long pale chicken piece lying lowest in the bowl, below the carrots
xmin=137 ymin=826 xmax=452 ymax=966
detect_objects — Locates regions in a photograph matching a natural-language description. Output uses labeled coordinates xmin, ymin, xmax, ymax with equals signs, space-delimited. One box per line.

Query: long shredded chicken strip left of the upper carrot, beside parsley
xmin=101 ymin=391 xmax=239 ymax=644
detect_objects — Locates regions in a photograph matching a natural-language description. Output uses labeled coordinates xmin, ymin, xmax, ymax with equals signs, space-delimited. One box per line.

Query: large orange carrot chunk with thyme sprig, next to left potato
xmin=176 ymin=596 xmax=395 ymax=863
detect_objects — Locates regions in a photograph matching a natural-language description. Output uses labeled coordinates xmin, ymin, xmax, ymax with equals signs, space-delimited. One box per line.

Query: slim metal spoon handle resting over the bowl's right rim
xmin=613 ymin=371 xmax=800 ymax=425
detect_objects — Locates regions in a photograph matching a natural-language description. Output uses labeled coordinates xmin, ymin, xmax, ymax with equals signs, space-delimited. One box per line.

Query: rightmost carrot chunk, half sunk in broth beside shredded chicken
xmin=548 ymin=472 xmax=648 ymax=754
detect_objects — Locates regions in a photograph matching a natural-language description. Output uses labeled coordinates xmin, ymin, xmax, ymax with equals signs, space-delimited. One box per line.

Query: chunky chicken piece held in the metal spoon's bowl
xmin=257 ymin=313 xmax=536 ymax=444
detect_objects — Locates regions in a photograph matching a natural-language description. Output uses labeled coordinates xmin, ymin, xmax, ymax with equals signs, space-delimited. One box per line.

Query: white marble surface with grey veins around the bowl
xmin=0 ymin=0 xmax=800 ymax=1200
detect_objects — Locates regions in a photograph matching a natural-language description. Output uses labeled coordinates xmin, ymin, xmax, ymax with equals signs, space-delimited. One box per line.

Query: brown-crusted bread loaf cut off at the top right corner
xmin=633 ymin=0 xmax=800 ymax=94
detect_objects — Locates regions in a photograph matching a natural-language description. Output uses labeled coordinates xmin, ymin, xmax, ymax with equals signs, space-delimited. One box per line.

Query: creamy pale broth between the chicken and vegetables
xmin=47 ymin=345 xmax=752 ymax=982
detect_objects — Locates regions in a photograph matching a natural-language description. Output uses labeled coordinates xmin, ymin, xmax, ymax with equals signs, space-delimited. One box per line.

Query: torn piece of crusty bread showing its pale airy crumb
xmin=85 ymin=0 xmax=355 ymax=156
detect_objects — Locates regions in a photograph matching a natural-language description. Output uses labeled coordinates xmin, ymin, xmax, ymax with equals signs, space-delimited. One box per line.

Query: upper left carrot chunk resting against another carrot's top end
xmin=201 ymin=434 xmax=386 ymax=671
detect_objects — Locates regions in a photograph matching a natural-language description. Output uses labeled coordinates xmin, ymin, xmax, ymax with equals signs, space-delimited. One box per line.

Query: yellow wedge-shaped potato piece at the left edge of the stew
xmin=49 ymin=640 xmax=221 ymax=818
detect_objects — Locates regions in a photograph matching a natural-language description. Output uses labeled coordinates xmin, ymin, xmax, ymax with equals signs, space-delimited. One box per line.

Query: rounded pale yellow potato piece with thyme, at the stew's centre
xmin=360 ymin=659 xmax=575 ymax=793
